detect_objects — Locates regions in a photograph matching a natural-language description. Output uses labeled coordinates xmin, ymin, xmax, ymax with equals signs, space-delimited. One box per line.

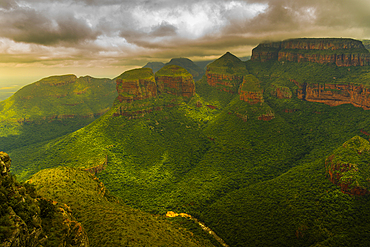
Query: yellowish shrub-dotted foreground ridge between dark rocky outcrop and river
xmin=30 ymin=167 xmax=217 ymax=246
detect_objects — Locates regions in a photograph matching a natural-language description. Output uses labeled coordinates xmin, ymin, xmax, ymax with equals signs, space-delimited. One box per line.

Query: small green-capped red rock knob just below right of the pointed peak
xmin=239 ymin=75 xmax=264 ymax=104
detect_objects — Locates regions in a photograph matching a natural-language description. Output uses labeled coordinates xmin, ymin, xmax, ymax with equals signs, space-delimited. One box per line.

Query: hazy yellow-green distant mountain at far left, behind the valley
xmin=0 ymin=75 xmax=117 ymax=152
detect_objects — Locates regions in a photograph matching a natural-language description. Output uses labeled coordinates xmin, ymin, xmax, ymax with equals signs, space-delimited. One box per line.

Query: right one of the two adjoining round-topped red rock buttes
xmin=155 ymin=65 xmax=195 ymax=98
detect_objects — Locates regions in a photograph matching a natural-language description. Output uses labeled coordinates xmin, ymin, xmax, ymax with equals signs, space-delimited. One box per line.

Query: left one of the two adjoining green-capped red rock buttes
xmin=116 ymin=68 xmax=157 ymax=102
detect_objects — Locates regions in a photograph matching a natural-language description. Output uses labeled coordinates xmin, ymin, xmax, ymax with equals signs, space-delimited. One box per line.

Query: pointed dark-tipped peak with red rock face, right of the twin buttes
xmin=206 ymin=52 xmax=248 ymax=93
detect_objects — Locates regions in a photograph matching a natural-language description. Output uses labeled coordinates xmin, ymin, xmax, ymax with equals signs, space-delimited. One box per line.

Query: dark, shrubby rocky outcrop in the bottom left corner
xmin=0 ymin=152 xmax=89 ymax=247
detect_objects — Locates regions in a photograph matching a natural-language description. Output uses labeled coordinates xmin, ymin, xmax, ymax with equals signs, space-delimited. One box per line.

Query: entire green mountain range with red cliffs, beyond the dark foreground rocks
xmin=0 ymin=38 xmax=370 ymax=246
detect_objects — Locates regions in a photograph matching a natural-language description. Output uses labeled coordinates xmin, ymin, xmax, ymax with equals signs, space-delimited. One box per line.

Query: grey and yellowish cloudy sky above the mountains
xmin=0 ymin=0 xmax=370 ymax=88
